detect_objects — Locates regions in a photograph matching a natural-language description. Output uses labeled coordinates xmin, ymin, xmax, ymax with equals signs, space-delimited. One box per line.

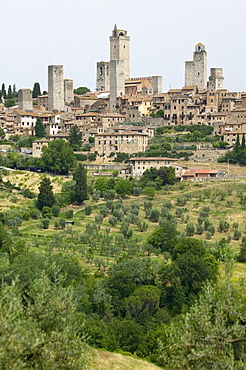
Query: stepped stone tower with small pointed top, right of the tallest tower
xmin=185 ymin=42 xmax=207 ymax=90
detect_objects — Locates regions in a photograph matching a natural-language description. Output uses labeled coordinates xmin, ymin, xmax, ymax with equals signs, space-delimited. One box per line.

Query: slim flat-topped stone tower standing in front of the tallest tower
xmin=109 ymin=59 xmax=125 ymax=112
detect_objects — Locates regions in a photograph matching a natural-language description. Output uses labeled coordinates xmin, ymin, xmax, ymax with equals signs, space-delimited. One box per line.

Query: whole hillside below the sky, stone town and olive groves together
xmin=0 ymin=26 xmax=246 ymax=370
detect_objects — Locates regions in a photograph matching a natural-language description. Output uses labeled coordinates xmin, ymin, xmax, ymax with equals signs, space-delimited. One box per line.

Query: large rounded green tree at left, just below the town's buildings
xmin=41 ymin=139 xmax=75 ymax=175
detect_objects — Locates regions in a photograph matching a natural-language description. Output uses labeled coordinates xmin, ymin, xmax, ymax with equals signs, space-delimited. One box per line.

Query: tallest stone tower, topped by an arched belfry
xmin=109 ymin=25 xmax=130 ymax=80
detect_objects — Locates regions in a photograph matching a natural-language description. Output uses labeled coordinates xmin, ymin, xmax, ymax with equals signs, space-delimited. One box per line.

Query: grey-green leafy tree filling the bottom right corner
xmin=159 ymin=261 xmax=246 ymax=370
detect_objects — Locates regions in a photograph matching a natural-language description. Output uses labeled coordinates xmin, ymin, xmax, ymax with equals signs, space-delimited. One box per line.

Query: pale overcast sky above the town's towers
xmin=0 ymin=0 xmax=246 ymax=92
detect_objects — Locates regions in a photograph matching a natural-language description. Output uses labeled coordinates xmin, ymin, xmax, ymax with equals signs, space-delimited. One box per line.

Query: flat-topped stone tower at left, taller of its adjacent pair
xmin=48 ymin=65 xmax=64 ymax=112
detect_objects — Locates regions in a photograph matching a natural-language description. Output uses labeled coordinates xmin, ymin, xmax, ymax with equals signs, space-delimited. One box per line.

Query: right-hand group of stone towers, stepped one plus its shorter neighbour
xmin=185 ymin=42 xmax=224 ymax=91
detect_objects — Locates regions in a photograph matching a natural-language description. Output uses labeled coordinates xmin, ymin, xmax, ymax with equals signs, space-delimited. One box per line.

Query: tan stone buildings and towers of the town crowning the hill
xmin=0 ymin=25 xmax=246 ymax=181
